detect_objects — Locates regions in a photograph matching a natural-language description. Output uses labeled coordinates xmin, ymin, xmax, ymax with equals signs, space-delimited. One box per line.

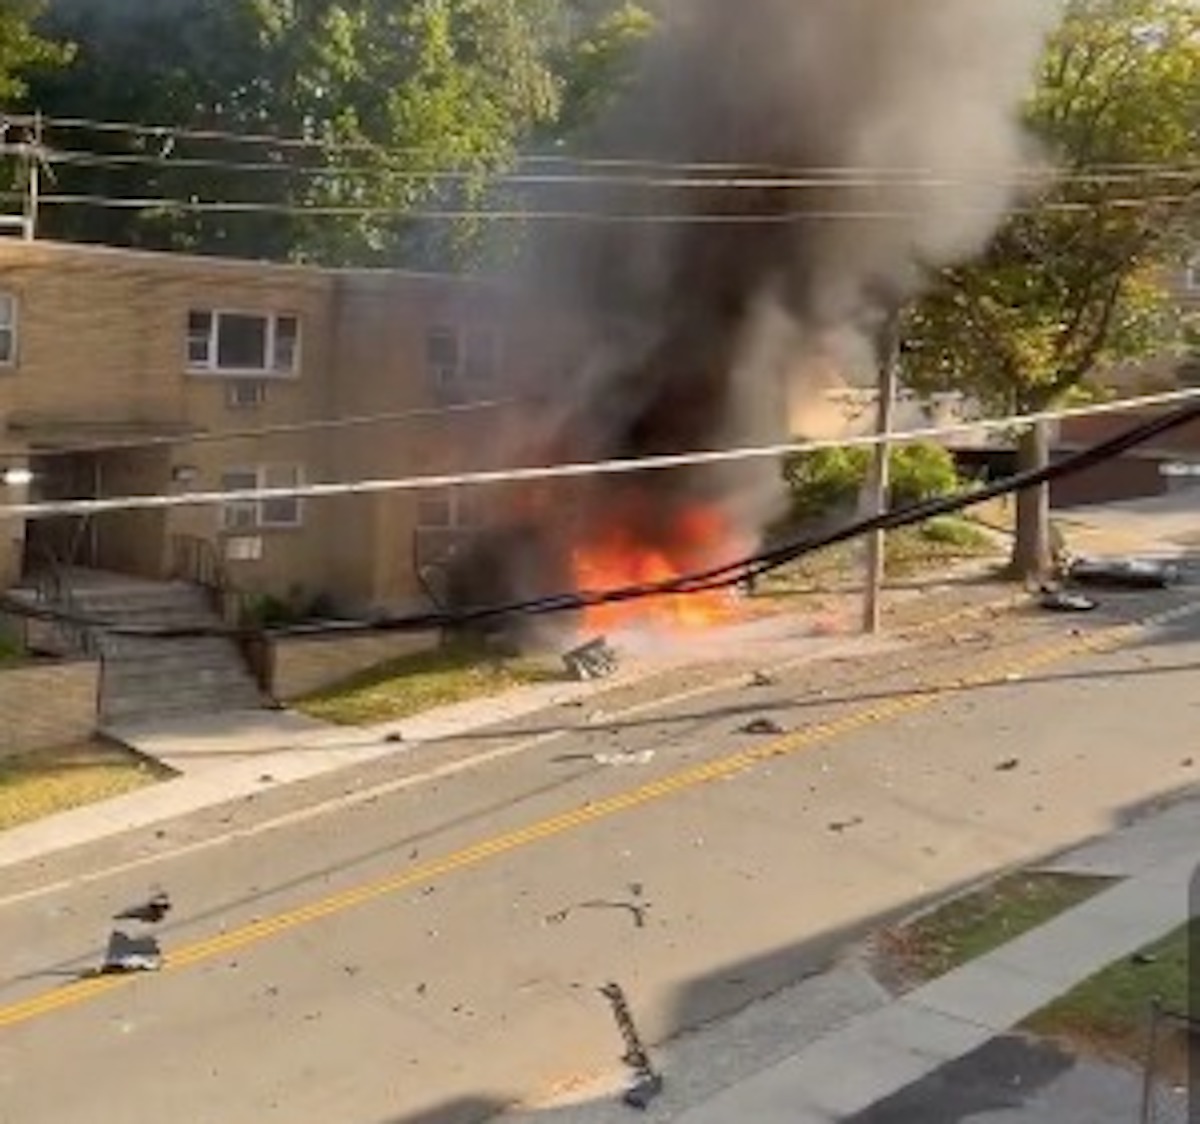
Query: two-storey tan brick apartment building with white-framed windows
xmin=0 ymin=239 xmax=525 ymax=611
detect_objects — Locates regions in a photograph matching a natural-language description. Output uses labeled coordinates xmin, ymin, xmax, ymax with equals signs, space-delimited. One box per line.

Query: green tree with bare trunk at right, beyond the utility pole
xmin=905 ymin=0 xmax=1200 ymax=577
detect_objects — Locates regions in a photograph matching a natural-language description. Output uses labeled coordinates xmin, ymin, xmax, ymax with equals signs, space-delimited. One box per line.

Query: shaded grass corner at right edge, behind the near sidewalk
xmin=1024 ymin=919 xmax=1200 ymax=1080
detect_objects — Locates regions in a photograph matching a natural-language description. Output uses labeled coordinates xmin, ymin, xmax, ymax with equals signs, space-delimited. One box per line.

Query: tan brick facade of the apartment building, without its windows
xmin=0 ymin=240 xmax=530 ymax=612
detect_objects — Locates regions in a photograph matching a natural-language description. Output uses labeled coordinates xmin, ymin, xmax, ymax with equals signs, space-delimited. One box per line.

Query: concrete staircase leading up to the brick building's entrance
xmin=61 ymin=571 xmax=268 ymax=729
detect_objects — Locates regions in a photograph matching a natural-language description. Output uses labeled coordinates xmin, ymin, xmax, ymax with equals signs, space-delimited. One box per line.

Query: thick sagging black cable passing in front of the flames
xmin=0 ymin=402 xmax=1200 ymax=639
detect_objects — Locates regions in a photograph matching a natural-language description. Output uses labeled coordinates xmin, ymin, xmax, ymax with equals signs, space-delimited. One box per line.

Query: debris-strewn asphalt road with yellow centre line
xmin=0 ymin=585 xmax=1200 ymax=1124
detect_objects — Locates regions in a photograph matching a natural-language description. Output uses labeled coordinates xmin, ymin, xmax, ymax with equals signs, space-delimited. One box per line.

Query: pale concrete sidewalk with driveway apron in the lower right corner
xmin=505 ymin=798 xmax=1200 ymax=1124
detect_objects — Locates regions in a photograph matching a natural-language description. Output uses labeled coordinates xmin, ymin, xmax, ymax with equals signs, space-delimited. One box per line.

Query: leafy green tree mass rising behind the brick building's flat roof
xmin=21 ymin=0 xmax=562 ymax=264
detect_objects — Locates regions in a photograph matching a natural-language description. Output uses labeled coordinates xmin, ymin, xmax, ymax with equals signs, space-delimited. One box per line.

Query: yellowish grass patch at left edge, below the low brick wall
xmin=0 ymin=743 xmax=167 ymax=830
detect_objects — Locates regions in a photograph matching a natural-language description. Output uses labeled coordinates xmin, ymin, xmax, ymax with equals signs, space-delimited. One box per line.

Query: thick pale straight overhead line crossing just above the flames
xmin=0 ymin=389 xmax=1200 ymax=519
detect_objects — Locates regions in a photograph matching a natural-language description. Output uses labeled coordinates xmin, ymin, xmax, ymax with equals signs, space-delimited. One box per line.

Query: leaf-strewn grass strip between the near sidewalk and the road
xmin=877 ymin=873 xmax=1110 ymax=990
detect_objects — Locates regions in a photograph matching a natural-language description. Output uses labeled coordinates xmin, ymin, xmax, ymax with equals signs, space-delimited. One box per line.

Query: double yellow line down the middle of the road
xmin=0 ymin=603 xmax=1200 ymax=1028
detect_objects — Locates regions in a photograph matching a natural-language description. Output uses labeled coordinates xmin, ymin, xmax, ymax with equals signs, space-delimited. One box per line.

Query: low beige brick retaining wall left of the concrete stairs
xmin=0 ymin=661 xmax=100 ymax=758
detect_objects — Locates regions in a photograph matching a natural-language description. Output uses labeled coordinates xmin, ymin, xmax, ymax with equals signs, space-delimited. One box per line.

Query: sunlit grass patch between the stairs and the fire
xmin=295 ymin=645 xmax=563 ymax=726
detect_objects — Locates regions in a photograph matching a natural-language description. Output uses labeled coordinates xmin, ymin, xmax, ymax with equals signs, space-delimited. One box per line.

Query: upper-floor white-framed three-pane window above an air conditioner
xmin=187 ymin=309 xmax=300 ymax=378
